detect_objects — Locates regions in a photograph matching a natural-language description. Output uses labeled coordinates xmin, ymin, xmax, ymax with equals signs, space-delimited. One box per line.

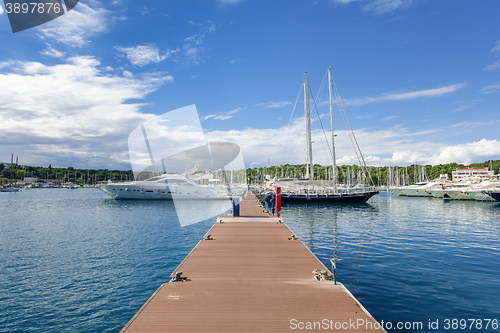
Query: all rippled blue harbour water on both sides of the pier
xmin=0 ymin=189 xmax=500 ymax=332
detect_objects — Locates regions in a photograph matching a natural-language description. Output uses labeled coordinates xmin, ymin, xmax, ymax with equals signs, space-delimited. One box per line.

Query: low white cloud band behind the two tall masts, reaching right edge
xmin=205 ymin=118 xmax=500 ymax=167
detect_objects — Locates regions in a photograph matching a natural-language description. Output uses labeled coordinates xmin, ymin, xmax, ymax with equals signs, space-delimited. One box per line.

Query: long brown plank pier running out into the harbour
xmin=121 ymin=193 xmax=385 ymax=333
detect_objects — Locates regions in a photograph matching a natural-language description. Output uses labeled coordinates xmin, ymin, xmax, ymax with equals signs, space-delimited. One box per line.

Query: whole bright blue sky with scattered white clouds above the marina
xmin=0 ymin=0 xmax=500 ymax=169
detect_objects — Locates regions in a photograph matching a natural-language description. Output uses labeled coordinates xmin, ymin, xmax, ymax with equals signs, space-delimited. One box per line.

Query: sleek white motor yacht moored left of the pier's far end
xmin=99 ymin=174 xmax=230 ymax=200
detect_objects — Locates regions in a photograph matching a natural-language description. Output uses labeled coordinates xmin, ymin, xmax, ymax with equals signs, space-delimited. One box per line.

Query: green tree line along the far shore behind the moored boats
xmin=0 ymin=160 xmax=500 ymax=186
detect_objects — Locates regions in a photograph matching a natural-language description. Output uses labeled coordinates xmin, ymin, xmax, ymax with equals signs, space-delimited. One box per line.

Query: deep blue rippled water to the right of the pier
xmin=283 ymin=193 xmax=500 ymax=332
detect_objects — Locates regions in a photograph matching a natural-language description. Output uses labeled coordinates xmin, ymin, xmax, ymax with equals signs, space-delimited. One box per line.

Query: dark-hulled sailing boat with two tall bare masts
xmin=281 ymin=68 xmax=379 ymax=204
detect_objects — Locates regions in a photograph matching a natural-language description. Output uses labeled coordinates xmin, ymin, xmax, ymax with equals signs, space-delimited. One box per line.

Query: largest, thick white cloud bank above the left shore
xmin=0 ymin=56 xmax=173 ymax=167
